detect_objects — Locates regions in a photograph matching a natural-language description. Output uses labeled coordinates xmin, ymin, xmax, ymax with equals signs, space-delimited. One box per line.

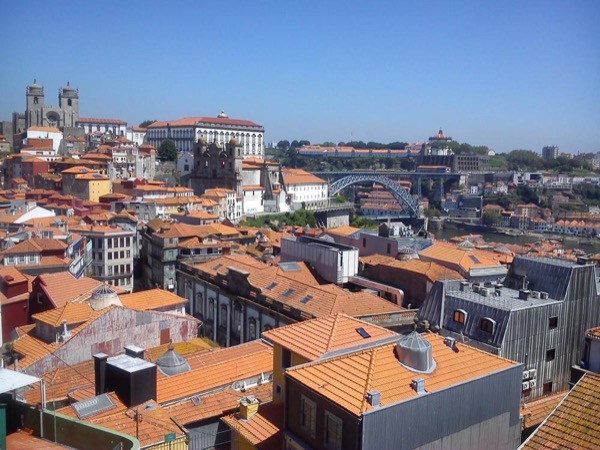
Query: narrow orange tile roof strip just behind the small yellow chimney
xmin=165 ymin=382 xmax=273 ymax=425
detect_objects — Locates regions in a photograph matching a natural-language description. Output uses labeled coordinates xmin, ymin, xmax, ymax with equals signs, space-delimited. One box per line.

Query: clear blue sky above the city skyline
xmin=0 ymin=0 xmax=600 ymax=153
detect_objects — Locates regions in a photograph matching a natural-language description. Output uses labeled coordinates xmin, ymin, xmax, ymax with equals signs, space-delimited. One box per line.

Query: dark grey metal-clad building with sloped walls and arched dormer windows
xmin=419 ymin=256 xmax=600 ymax=401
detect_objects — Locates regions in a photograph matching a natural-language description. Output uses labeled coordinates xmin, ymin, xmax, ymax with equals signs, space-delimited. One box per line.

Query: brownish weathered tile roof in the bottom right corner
xmin=520 ymin=374 xmax=600 ymax=449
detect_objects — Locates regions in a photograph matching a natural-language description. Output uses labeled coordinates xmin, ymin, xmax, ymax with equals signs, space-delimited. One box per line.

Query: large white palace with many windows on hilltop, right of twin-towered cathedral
xmin=146 ymin=112 xmax=265 ymax=158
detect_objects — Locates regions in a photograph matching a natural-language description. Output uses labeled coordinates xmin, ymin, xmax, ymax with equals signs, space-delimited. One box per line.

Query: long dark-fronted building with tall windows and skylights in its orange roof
xmin=177 ymin=255 xmax=414 ymax=347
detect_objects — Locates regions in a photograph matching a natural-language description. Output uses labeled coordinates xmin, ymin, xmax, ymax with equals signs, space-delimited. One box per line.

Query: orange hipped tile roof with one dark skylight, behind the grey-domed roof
xmin=263 ymin=313 xmax=398 ymax=361
